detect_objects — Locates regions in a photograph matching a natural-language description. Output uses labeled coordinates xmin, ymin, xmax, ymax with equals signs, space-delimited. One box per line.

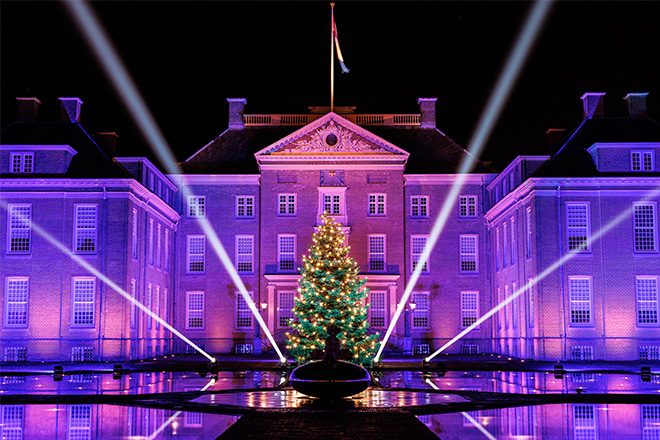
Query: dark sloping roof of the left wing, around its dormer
xmin=0 ymin=121 xmax=132 ymax=179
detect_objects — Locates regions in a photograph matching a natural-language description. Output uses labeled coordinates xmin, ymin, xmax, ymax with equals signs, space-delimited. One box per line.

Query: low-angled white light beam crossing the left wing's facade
xmin=0 ymin=199 xmax=216 ymax=362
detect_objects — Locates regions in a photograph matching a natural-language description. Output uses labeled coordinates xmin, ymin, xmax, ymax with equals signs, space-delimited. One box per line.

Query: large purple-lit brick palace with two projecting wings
xmin=0 ymin=93 xmax=660 ymax=361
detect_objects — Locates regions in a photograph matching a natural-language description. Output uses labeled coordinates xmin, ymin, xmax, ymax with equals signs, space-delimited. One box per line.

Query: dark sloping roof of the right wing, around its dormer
xmin=533 ymin=117 xmax=660 ymax=177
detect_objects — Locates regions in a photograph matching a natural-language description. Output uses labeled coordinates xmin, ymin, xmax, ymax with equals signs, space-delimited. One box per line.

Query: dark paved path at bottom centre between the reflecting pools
xmin=217 ymin=408 xmax=438 ymax=440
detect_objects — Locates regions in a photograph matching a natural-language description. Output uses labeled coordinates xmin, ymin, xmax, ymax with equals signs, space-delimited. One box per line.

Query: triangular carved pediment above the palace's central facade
xmin=255 ymin=112 xmax=408 ymax=163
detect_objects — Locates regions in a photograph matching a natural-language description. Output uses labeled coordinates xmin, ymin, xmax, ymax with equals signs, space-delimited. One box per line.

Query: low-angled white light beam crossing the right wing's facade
xmin=424 ymin=189 xmax=660 ymax=362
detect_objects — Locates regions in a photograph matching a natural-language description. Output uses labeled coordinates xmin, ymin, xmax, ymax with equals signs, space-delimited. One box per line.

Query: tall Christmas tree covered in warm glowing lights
xmin=287 ymin=213 xmax=378 ymax=364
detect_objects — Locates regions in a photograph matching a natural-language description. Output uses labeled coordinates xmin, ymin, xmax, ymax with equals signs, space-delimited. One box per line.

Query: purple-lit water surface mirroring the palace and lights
xmin=0 ymin=371 xmax=660 ymax=440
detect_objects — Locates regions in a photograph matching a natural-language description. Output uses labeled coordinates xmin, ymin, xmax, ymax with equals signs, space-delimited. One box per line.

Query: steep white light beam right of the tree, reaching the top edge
xmin=374 ymin=0 xmax=552 ymax=362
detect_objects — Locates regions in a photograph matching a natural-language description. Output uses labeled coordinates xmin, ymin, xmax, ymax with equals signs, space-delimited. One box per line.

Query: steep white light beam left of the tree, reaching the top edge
xmin=63 ymin=1 xmax=286 ymax=362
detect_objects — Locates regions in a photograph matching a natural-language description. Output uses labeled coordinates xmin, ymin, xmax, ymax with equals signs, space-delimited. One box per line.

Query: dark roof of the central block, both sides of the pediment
xmin=181 ymin=126 xmax=495 ymax=174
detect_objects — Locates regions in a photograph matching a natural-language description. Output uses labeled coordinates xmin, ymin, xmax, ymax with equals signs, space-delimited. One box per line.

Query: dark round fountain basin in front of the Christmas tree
xmin=289 ymin=361 xmax=371 ymax=399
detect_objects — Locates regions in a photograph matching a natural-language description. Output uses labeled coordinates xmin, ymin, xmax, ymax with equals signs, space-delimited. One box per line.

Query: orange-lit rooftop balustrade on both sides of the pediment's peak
xmin=243 ymin=113 xmax=420 ymax=127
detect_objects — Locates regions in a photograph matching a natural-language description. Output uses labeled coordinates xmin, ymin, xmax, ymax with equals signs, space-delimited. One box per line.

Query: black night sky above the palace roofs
xmin=0 ymin=1 xmax=660 ymax=169
